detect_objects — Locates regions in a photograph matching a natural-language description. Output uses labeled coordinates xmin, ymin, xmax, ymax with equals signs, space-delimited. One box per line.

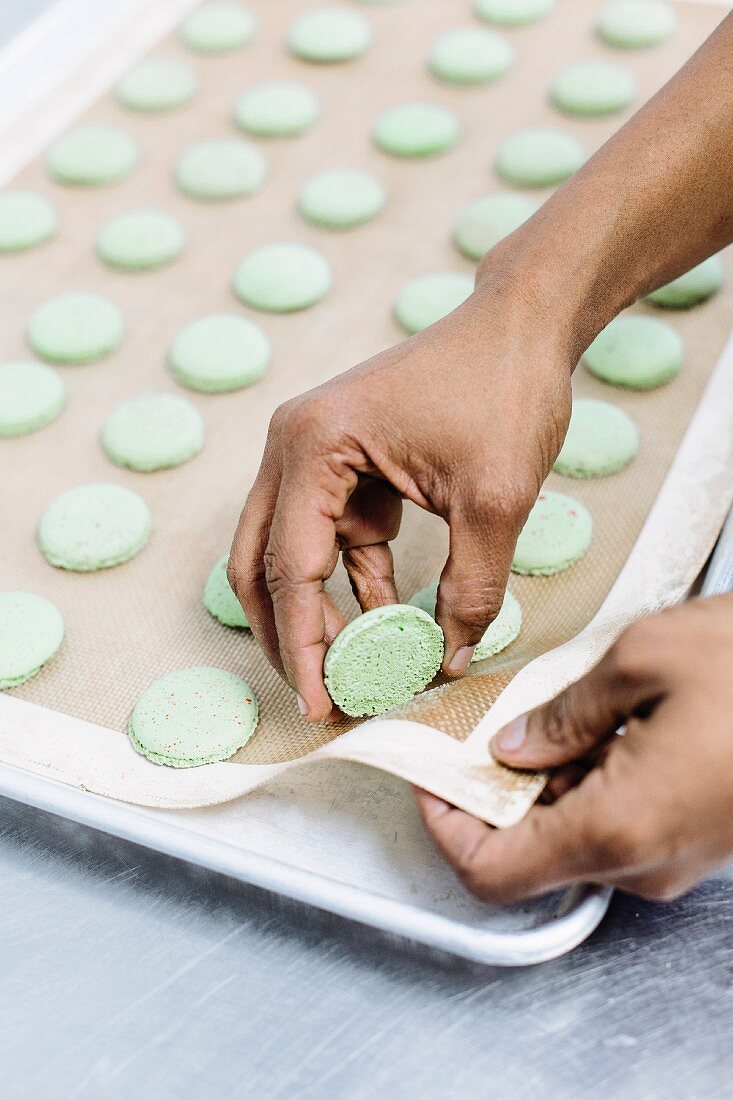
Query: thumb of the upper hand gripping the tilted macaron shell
xmin=436 ymin=505 xmax=521 ymax=675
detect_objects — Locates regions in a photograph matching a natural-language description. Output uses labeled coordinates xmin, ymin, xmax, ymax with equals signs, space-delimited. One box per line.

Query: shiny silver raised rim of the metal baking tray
xmin=0 ymin=0 xmax=731 ymax=966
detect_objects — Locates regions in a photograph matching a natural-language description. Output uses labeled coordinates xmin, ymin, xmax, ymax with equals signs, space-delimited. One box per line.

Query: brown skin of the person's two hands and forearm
xmin=229 ymin=17 xmax=733 ymax=900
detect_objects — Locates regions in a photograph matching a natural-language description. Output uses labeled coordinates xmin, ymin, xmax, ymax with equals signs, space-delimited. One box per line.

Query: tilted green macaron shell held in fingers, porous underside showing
xmin=324 ymin=604 xmax=444 ymax=717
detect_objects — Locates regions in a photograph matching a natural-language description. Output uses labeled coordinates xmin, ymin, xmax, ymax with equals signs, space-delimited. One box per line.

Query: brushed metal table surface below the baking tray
xmin=0 ymin=0 xmax=733 ymax=1100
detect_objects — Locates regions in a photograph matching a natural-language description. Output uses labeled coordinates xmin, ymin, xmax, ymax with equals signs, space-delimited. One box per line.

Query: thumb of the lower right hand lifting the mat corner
xmin=491 ymin=639 xmax=659 ymax=768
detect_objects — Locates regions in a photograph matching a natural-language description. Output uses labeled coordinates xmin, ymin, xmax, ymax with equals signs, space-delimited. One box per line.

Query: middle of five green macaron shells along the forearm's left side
xmin=494 ymin=127 xmax=586 ymax=187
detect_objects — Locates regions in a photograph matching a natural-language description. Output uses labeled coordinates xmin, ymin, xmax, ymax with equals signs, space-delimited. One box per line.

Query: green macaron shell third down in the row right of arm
xmin=554 ymin=397 xmax=638 ymax=477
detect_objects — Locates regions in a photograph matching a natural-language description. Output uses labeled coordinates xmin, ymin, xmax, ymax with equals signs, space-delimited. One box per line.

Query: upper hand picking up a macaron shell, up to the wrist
xmin=229 ymin=265 xmax=577 ymax=722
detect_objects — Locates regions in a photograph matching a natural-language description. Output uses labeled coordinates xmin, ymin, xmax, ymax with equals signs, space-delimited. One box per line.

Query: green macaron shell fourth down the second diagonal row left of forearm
xmin=298 ymin=168 xmax=386 ymax=229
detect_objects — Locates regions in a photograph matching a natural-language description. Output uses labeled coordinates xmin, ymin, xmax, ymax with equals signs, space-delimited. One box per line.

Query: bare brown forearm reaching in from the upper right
xmin=479 ymin=15 xmax=733 ymax=362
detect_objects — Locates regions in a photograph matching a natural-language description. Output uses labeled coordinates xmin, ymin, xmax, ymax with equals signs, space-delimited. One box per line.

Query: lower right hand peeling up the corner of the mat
xmin=417 ymin=595 xmax=733 ymax=902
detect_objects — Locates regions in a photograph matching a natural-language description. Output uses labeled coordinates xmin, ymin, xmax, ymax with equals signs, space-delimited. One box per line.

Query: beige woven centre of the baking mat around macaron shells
xmin=0 ymin=0 xmax=731 ymax=827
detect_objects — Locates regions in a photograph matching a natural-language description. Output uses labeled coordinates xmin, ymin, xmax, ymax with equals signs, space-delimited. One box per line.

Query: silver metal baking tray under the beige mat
xmin=0 ymin=0 xmax=733 ymax=966
